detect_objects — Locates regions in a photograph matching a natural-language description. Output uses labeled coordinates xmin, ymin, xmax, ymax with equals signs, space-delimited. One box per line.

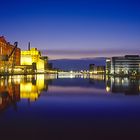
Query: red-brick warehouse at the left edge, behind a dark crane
xmin=0 ymin=36 xmax=21 ymax=73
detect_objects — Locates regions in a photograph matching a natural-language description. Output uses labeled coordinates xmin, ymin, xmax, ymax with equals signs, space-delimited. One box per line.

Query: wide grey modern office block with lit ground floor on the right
xmin=106 ymin=55 xmax=140 ymax=76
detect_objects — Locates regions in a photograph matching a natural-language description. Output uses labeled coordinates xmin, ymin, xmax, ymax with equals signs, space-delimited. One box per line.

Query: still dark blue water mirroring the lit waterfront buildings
xmin=0 ymin=75 xmax=140 ymax=140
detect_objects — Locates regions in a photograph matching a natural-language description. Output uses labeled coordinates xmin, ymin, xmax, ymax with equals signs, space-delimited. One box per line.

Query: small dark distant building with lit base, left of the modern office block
xmin=89 ymin=64 xmax=105 ymax=74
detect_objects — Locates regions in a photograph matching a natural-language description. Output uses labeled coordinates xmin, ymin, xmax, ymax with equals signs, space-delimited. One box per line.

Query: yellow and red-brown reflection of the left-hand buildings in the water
xmin=0 ymin=75 xmax=55 ymax=111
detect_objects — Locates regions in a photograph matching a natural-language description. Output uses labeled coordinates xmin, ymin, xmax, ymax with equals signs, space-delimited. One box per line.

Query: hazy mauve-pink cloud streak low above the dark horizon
xmin=41 ymin=49 xmax=140 ymax=59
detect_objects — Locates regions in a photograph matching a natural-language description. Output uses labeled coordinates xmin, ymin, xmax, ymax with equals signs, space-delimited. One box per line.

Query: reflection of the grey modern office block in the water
xmin=106 ymin=77 xmax=140 ymax=95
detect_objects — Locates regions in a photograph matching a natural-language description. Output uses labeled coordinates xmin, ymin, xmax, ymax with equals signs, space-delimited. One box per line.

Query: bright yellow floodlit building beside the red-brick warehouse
xmin=20 ymin=48 xmax=46 ymax=72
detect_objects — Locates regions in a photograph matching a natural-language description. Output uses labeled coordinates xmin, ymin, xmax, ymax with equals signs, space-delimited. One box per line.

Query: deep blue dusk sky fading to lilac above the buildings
xmin=0 ymin=0 xmax=140 ymax=59
